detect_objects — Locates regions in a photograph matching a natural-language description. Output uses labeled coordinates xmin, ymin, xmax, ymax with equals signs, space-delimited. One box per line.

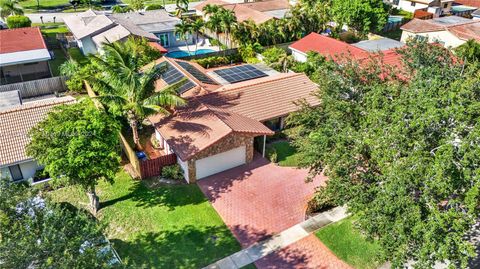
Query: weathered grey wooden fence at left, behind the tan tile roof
xmin=0 ymin=77 xmax=67 ymax=98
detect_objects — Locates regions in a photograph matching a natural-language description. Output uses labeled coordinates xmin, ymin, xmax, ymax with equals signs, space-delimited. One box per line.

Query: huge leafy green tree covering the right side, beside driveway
xmin=288 ymin=38 xmax=480 ymax=268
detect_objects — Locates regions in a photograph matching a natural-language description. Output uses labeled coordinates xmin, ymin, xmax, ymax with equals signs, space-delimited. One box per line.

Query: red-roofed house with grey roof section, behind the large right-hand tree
xmin=289 ymin=33 xmax=404 ymax=66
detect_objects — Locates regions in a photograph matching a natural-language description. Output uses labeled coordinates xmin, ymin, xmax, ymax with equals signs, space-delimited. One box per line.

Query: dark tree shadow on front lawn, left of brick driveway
xmin=100 ymin=181 xmax=206 ymax=210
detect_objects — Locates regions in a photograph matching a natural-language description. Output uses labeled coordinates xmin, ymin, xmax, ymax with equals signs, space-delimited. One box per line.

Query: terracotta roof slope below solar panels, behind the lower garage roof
xmin=197 ymin=73 xmax=319 ymax=121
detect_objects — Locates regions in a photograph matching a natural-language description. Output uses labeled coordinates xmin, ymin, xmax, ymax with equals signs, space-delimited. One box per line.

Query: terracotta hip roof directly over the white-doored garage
xmin=149 ymin=101 xmax=274 ymax=161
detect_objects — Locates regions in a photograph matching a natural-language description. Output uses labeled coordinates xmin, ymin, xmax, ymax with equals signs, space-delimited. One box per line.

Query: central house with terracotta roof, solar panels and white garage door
xmin=149 ymin=57 xmax=318 ymax=183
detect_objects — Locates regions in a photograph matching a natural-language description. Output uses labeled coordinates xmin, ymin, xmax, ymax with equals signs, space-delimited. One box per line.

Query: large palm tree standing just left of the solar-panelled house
xmin=89 ymin=42 xmax=185 ymax=149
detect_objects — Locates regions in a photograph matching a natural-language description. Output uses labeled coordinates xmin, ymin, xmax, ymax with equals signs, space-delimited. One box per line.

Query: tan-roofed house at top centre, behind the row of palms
xmin=195 ymin=0 xmax=290 ymax=24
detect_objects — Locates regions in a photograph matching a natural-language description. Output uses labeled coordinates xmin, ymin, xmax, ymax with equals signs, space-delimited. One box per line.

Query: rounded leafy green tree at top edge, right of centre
xmin=330 ymin=0 xmax=388 ymax=34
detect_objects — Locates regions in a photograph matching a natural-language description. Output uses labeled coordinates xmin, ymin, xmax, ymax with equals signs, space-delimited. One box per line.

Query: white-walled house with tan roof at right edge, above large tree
xmin=400 ymin=16 xmax=480 ymax=48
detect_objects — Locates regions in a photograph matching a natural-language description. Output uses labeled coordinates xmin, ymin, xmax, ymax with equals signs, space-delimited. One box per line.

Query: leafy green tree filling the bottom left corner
xmin=0 ymin=177 xmax=120 ymax=268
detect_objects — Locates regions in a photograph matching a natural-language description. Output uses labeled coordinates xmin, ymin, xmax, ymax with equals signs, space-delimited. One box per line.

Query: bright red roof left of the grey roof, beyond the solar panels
xmin=290 ymin=33 xmax=369 ymax=59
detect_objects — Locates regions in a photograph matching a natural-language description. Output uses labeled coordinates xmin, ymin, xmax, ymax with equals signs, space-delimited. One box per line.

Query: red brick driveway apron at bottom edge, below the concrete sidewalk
xmin=255 ymin=234 xmax=352 ymax=269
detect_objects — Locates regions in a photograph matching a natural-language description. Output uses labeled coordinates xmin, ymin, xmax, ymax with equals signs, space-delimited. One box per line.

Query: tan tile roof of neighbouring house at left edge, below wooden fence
xmin=0 ymin=96 xmax=75 ymax=166
